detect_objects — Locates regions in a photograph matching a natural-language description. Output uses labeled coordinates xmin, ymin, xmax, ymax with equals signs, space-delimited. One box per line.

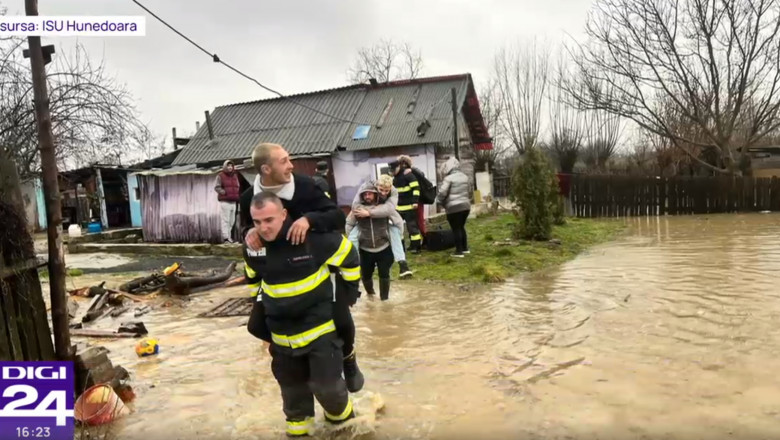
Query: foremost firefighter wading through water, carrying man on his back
xmin=250 ymin=191 xmax=360 ymax=437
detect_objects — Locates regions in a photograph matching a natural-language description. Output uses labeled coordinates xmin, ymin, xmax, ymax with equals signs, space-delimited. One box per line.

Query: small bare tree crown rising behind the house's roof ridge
xmin=347 ymin=40 xmax=423 ymax=84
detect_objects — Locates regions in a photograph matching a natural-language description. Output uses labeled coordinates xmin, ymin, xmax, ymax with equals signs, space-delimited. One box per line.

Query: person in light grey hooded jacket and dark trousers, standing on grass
xmin=436 ymin=157 xmax=471 ymax=258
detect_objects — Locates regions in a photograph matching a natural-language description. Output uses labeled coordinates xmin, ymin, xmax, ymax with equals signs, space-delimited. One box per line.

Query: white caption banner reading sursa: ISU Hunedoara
xmin=0 ymin=15 xmax=146 ymax=37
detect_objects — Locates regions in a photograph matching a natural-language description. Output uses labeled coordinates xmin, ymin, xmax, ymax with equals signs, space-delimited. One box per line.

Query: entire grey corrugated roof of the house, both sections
xmin=173 ymin=74 xmax=471 ymax=165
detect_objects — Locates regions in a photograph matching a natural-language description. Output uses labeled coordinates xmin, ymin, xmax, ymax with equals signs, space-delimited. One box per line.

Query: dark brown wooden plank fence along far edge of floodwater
xmin=568 ymin=175 xmax=780 ymax=217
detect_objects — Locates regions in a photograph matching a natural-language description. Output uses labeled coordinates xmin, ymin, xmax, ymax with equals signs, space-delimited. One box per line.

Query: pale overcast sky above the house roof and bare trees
xmin=0 ymin=0 xmax=592 ymax=148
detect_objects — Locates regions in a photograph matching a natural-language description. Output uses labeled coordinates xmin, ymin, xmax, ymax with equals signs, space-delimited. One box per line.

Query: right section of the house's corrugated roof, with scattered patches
xmin=339 ymin=76 xmax=468 ymax=151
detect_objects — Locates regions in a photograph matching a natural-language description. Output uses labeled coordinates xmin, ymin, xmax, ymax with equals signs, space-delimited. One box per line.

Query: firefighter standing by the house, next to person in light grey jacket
xmin=388 ymin=155 xmax=422 ymax=254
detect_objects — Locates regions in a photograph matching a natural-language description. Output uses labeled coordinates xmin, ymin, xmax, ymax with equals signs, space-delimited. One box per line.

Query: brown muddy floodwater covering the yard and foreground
xmin=67 ymin=214 xmax=780 ymax=440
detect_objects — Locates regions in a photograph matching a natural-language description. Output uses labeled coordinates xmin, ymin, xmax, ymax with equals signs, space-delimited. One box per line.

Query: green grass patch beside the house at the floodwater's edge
xmin=402 ymin=213 xmax=625 ymax=283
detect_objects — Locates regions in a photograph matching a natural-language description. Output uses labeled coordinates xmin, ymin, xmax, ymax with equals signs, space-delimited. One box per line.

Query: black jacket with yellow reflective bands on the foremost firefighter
xmin=260 ymin=219 xmax=360 ymax=355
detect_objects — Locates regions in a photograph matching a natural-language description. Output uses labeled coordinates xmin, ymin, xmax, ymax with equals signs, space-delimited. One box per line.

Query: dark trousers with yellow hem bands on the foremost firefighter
xmin=271 ymin=335 xmax=354 ymax=435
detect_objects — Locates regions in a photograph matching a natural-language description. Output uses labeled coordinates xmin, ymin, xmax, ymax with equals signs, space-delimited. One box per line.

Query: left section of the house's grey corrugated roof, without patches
xmin=173 ymin=86 xmax=366 ymax=165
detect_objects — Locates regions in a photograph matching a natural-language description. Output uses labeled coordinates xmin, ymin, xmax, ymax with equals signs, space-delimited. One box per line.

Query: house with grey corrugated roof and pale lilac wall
xmin=173 ymin=74 xmax=493 ymax=217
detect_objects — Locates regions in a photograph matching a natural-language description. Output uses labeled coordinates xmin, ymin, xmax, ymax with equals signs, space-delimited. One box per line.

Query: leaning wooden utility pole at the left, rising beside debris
xmin=24 ymin=0 xmax=72 ymax=360
